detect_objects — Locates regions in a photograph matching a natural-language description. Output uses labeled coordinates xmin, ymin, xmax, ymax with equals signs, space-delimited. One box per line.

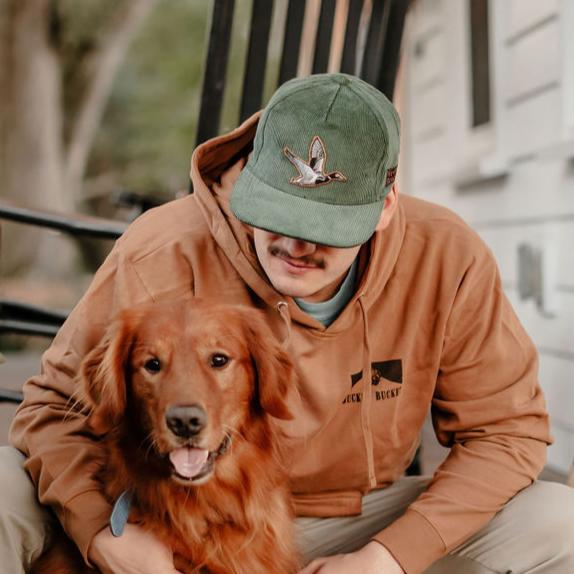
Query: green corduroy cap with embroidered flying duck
xmin=231 ymin=74 xmax=400 ymax=247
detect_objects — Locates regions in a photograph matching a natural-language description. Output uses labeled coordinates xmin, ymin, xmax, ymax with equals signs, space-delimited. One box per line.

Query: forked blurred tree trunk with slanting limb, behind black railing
xmin=0 ymin=0 xmax=157 ymax=277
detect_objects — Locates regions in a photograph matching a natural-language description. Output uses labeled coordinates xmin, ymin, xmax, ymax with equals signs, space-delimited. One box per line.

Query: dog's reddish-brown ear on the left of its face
xmin=81 ymin=311 xmax=139 ymax=433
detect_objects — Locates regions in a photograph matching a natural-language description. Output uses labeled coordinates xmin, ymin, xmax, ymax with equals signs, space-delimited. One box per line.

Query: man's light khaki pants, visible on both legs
xmin=0 ymin=447 xmax=574 ymax=574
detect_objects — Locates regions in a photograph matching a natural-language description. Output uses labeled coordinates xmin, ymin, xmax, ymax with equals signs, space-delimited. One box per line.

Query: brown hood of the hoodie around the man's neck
xmin=190 ymin=113 xmax=406 ymax=334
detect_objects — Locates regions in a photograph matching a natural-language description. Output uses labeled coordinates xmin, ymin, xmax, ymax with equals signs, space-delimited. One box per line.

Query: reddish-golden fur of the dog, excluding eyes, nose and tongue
xmin=33 ymin=299 xmax=298 ymax=574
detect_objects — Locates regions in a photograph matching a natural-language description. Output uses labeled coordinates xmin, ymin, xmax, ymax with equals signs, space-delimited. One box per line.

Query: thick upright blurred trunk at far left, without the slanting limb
xmin=0 ymin=0 xmax=73 ymax=274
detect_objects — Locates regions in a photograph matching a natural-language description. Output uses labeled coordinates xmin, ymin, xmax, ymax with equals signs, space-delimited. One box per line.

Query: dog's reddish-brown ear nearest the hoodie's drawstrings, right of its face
xmin=244 ymin=311 xmax=297 ymax=420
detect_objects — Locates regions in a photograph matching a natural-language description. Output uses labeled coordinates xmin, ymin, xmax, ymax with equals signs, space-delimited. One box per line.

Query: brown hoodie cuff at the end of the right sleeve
xmin=373 ymin=510 xmax=446 ymax=574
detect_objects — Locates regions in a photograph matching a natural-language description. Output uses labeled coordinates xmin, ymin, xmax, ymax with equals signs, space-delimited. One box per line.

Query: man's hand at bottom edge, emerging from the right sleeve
xmin=299 ymin=541 xmax=404 ymax=574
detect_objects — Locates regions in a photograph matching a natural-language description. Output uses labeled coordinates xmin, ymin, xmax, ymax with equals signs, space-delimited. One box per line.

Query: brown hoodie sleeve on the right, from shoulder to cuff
xmin=375 ymin=247 xmax=551 ymax=574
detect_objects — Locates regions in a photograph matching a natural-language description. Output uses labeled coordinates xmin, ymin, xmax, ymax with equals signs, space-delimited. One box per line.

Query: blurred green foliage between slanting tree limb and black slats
xmin=88 ymin=0 xmax=211 ymax=194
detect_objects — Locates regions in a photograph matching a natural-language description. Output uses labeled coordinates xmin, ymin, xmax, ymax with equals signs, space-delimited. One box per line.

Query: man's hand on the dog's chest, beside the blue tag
xmin=88 ymin=524 xmax=181 ymax=574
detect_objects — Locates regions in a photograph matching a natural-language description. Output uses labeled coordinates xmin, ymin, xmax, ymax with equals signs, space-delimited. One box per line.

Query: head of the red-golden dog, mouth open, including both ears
xmin=82 ymin=299 xmax=294 ymax=484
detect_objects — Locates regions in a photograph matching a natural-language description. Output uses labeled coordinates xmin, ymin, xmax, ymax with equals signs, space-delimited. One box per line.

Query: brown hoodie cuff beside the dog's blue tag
xmin=63 ymin=490 xmax=112 ymax=567
